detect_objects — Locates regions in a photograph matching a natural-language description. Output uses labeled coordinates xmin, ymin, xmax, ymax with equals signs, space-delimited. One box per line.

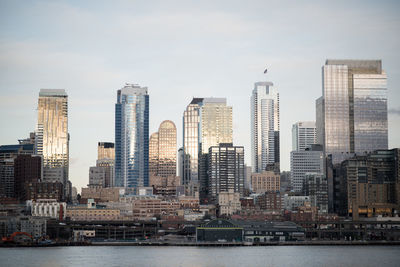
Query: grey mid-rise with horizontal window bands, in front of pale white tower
xmin=290 ymin=145 xmax=325 ymax=192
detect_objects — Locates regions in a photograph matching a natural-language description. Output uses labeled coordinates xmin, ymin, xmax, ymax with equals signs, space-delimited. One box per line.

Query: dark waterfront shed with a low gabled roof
xmin=196 ymin=219 xmax=243 ymax=242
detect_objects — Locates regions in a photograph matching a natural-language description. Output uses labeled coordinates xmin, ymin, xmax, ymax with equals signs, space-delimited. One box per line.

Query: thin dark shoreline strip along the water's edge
xmin=0 ymin=241 xmax=400 ymax=248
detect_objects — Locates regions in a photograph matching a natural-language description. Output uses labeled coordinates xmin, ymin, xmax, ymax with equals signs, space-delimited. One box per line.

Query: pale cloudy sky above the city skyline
xmin=0 ymin=0 xmax=400 ymax=193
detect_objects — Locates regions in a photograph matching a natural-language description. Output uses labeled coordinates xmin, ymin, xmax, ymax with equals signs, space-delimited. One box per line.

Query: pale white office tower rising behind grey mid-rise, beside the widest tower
xmin=292 ymin=121 xmax=317 ymax=151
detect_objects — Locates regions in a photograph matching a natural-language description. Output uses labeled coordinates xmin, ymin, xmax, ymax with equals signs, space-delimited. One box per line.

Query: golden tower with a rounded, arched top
xmin=149 ymin=120 xmax=179 ymax=187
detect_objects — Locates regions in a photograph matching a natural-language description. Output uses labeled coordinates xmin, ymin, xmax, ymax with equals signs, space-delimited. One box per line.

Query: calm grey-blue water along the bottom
xmin=0 ymin=246 xmax=400 ymax=267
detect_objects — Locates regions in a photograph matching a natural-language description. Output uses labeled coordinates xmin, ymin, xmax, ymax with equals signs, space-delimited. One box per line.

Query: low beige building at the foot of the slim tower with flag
xmin=251 ymin=171 xmax=281 ymax=194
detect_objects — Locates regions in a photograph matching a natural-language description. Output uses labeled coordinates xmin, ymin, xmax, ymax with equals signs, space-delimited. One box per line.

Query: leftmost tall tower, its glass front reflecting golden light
xmin=35 ymin=89 xmax=70 ymax=199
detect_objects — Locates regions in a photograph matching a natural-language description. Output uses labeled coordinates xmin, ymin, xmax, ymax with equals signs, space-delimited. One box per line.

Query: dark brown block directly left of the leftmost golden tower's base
xmin=14 ymin=155 xmax=42 ymax=201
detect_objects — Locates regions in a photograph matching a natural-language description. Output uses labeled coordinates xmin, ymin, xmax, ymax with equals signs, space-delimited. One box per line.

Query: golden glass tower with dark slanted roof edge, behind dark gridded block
xmin=182 ymin=98 xmax=232 ymax=194
